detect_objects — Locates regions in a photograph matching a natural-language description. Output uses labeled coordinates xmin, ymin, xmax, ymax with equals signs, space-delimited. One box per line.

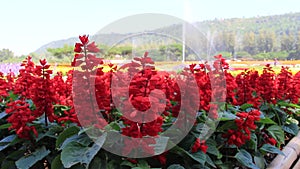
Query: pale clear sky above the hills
xmin=0 ymin=0 xmax=300 ymax=55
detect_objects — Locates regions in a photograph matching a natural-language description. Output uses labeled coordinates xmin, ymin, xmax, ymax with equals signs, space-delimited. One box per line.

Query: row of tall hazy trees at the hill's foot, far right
xmin=212 ymin=30 xmax=300 ymax=60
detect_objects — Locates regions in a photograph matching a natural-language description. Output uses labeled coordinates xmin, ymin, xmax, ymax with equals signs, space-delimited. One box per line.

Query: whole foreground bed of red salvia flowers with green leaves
xmin=0 ymin=36 xmax=300 ymax=169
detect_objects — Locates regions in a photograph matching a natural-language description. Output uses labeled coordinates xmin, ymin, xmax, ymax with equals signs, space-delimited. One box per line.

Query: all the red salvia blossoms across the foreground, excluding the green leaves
xmin=0 ymin=35 xmax=300 ymax=168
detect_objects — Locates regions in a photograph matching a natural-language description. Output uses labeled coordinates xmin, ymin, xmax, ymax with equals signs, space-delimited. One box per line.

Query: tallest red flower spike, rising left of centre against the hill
xmin=72 ymin=35 xmax=109 ymax=128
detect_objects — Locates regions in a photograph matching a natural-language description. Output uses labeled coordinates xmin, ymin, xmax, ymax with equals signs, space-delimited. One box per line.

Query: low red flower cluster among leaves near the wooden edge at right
xmin=223 ymin=109 xmax=260 ymax=147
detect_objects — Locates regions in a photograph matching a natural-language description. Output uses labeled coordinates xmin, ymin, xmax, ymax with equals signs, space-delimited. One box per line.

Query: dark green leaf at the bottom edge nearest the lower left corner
xmin=16 ymin=146 xmax=50 ymax=169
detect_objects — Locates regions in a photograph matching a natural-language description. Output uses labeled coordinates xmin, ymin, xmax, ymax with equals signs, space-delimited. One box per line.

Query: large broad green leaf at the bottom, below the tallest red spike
xmin=61 ymin=134 xmax=106 ymax=168
